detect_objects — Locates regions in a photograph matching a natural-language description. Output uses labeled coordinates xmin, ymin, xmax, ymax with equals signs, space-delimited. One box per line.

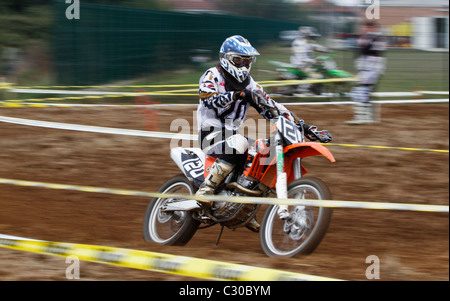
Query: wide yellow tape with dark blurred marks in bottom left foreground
xmin=0 ymin=239 xmax=340 ymax=281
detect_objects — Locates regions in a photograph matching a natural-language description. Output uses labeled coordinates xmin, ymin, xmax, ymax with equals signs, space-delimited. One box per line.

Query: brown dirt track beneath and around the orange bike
xmin=0 ymin=104 xmax=449 ymax=281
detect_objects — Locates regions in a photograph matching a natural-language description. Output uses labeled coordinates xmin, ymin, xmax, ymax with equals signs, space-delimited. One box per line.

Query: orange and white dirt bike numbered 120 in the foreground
xmin=143 ymin=98 xmax=335 ymax=257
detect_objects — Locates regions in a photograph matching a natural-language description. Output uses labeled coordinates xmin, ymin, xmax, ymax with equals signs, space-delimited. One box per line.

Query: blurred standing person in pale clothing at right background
xmin=347 ymin=21 xmax=386 ymax=124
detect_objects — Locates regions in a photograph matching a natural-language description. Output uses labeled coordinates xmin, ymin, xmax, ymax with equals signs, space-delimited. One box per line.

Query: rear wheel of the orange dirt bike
xmin=143 ymin=175 xmax=200 ymax=246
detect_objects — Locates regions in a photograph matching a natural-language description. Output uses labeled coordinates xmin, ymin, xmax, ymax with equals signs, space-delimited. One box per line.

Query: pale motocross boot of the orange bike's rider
xmin=195 ymin=159 xmax=234 ymax=208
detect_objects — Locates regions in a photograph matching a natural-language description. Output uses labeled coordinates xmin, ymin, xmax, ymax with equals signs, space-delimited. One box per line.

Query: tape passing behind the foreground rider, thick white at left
xmin=0 ymin=116 xmax=449 ymax=153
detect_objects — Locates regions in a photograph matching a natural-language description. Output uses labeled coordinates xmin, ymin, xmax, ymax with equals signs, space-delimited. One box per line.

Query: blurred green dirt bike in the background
xmin=269 ymin=55 xmax=352 ymax=97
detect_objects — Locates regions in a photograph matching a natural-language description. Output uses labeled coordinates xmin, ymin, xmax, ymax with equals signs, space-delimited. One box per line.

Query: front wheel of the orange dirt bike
xmin=260 ymin=178 xmax=332 ymax=257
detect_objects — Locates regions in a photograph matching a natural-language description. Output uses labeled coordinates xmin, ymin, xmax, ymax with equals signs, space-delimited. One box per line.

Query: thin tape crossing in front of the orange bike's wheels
xmin=0 ymin=178 xmax=449 ymax=212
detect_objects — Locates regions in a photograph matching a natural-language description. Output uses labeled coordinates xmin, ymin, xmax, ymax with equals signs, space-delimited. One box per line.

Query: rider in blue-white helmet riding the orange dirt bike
xmin=196 ymin=35 xmax=331 ymax=225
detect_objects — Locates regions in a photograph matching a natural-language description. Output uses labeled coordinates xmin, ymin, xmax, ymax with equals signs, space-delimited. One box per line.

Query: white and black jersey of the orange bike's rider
xmin=197 ymin=67 xmax=287 ymax=132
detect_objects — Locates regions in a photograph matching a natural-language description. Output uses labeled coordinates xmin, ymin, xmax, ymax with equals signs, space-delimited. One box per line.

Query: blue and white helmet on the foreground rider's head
xmin=220 ymin=36 xmax=259 ymax=83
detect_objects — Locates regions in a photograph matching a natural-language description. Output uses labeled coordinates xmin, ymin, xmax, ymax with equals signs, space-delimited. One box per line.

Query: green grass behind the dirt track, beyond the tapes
xmin=2 ymin=45 xmax=449 ymax=103
